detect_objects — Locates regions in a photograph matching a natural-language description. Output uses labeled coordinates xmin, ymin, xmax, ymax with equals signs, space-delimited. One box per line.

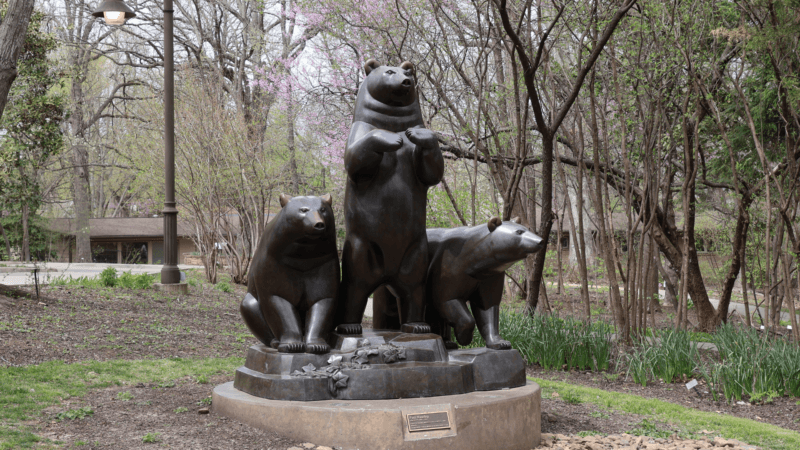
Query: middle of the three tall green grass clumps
xmin=627 ymin=329 xmax=699 ymax=386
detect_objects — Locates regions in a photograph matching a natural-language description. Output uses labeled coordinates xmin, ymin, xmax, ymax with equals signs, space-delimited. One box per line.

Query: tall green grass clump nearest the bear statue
xmin=462 ymin=308 xmax=612 ymax=370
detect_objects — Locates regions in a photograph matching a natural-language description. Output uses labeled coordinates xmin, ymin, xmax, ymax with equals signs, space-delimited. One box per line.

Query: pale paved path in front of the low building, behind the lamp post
xmin=0 ymin=261 xmax=203 ymax=286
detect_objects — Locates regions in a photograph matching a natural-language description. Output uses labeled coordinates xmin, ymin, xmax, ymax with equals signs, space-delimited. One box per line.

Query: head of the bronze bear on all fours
xmin=486 ymin=217 xmax=544 ymax=270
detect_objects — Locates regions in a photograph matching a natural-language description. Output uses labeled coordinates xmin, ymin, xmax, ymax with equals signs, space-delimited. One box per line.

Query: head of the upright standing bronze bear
xmin=364 ymin=59 xmax=417 ymax=106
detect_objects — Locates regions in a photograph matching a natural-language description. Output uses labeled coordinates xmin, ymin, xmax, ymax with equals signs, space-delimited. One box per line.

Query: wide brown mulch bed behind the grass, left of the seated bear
xmin=0 ymin=286 xmax=253 ymax=365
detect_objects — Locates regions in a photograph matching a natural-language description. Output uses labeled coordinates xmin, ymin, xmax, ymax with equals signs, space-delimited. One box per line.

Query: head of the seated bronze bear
xmin=280 ymin=194 xmax=335 ymax=241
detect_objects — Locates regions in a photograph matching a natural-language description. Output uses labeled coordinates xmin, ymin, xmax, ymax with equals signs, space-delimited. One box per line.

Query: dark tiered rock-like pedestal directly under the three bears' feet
xmin=234 ymin=330 xmax=525 ymax=401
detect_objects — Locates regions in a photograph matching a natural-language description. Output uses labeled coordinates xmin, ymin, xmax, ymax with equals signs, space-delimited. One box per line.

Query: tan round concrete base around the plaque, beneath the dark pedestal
xmin=212 ymin=381 xmax=542 ymax=450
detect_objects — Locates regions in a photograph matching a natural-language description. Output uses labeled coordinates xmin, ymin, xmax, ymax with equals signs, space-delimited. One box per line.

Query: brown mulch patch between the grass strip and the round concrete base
xmin=37 ymin=377 xmax=310 ymax=450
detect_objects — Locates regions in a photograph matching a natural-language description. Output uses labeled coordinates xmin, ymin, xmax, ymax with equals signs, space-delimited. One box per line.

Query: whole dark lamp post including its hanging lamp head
xmin=92 ymin=0 xmax=186 ymax=290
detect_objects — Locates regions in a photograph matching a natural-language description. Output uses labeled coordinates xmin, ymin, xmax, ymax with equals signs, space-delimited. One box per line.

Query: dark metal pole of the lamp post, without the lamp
xmin=161 ymin=0 xmax=181 ymax=284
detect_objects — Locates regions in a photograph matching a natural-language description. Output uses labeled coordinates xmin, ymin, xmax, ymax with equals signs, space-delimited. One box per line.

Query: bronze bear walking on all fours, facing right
xmin=373 ymin=217 xmax=543 ymax=350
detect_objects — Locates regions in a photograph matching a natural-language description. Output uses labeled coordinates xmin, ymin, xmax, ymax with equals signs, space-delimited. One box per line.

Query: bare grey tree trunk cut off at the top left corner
xmin=0 ymin=0 xmax=33 ymax=119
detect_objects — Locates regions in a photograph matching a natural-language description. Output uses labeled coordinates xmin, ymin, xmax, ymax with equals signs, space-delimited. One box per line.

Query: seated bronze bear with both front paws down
xmin=240 ymin=194 xmax=339 ymax=353
